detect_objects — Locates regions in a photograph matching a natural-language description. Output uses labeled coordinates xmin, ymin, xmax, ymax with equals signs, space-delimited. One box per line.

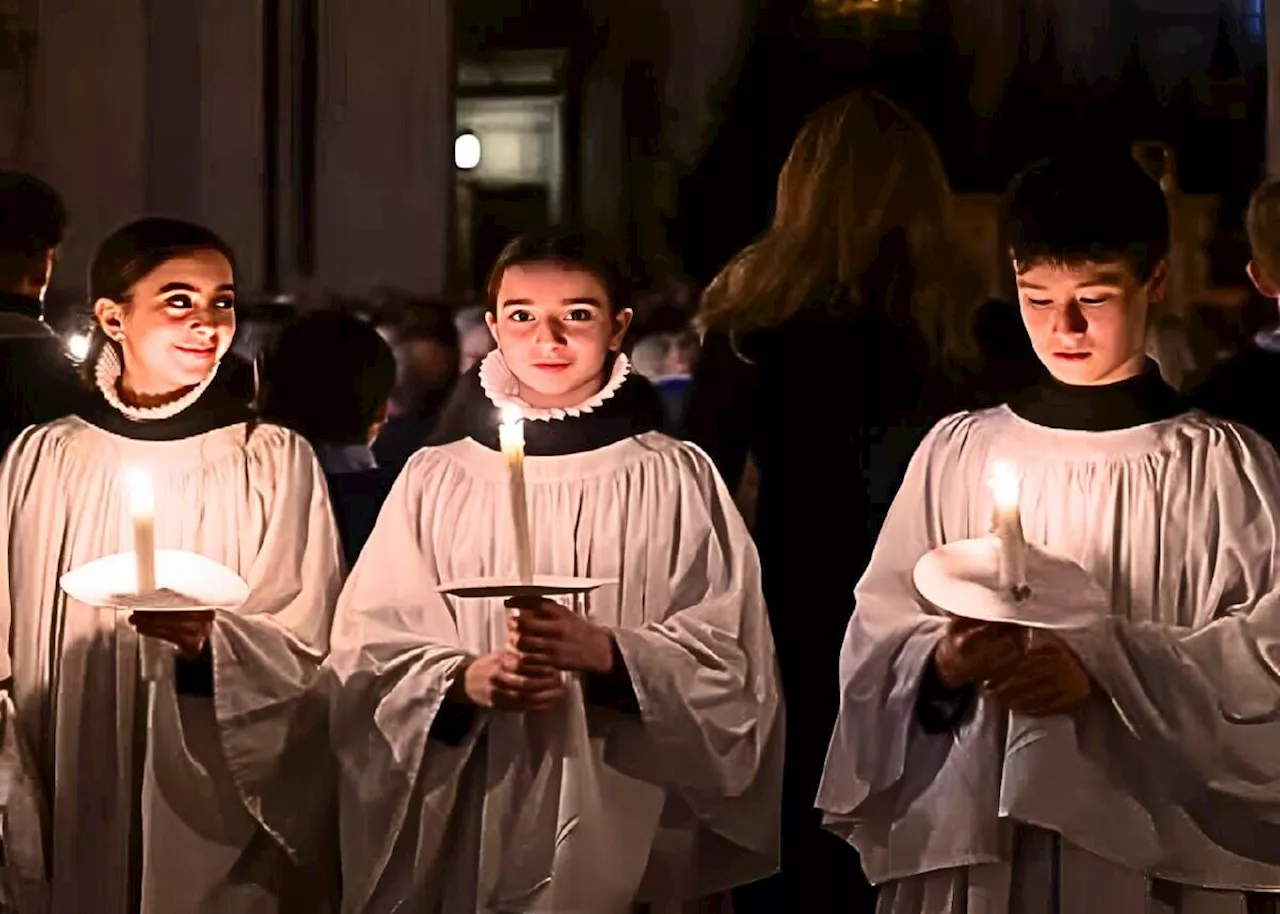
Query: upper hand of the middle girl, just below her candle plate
xmin=507 ymin=597 xmax=613 ymax=676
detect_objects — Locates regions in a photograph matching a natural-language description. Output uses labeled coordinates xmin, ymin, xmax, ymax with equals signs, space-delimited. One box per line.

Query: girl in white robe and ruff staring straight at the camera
xmin=325 ymin=233 xmax=782 ymax=914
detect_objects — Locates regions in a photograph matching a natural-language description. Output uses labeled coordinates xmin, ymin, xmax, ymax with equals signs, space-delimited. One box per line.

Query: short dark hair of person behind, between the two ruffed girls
xmin=262 ymin=311 xmax=396 ymax=444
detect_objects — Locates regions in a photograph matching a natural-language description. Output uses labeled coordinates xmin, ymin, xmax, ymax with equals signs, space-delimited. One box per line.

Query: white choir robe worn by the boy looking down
xmin=818 ymin=407 xmax=1280 ymax=914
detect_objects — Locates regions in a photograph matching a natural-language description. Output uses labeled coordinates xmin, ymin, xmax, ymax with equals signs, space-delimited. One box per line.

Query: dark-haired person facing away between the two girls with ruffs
xmin=262 ymin=311 xmax=396 ymax=568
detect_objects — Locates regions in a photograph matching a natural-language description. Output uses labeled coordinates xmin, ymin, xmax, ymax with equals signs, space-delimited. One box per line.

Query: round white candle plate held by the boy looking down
xmin=911 ymin=536 xmax=1111 ymax=631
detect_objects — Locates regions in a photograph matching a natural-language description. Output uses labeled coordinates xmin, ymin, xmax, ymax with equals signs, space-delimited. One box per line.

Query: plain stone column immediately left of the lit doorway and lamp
xmin=315 ymin=0 xmax=456 ymax=296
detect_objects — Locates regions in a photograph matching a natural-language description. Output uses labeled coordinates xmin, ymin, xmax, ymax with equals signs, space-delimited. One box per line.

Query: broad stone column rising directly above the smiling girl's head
xmin=24 ymin=0 xmax=264 ymax=291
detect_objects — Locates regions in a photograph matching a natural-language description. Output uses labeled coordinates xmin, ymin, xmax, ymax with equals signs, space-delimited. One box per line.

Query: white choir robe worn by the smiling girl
xmin=0 ymin=417 xmax=340 ymax=914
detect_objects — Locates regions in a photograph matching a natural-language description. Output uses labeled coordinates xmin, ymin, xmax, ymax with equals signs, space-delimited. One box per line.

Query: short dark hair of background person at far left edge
xmin=0 ymin=170 xmax=67 ymax=289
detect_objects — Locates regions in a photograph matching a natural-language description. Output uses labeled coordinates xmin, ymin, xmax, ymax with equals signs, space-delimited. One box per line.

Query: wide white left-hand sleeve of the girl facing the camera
xmin=325 ymin=454 xmax=485 ymax=910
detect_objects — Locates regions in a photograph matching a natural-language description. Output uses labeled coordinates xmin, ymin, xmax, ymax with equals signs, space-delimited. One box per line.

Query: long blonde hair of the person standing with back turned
xmin=698 ymin=91 xmax=986 ymax=361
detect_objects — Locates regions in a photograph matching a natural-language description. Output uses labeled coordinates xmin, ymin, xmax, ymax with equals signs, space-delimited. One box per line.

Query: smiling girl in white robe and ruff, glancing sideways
xmin=0 ymin=219 xmax=340 ymax=914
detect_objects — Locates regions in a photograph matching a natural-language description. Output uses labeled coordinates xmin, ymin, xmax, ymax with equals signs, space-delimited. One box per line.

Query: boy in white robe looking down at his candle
xmin=818 ymin=157 xmax=1280 ymax=914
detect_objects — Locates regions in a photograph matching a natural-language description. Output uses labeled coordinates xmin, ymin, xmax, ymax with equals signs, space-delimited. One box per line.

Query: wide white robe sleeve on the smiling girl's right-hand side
xmin=210 ymin=434 xmax=342 ymax=862
